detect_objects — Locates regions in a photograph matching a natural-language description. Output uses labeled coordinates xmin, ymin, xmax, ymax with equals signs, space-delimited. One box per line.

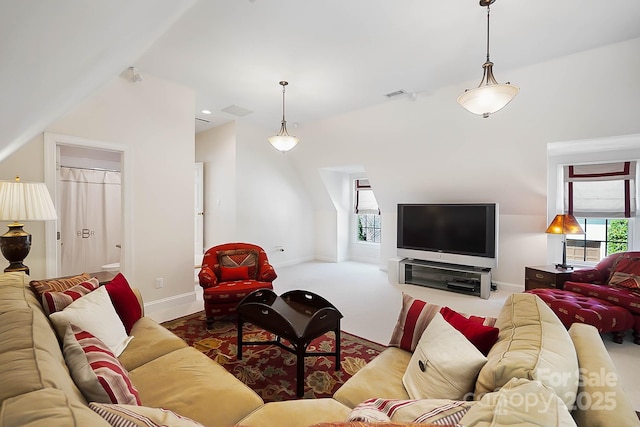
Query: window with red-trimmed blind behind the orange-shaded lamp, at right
xmin=564 ymin=162 xmax=636 ymax=263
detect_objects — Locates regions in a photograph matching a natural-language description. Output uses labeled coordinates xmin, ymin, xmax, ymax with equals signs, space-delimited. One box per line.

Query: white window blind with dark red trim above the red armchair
xmin=564 ymin=161 xmax=636 ymax=218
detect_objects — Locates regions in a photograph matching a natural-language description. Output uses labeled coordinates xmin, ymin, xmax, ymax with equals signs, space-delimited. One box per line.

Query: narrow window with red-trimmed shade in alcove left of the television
xmin=354 ymin=179 xmax=382 ymax=243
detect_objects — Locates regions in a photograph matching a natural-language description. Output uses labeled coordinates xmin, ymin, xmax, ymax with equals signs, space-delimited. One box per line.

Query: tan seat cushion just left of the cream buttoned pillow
xmin=333 ymin=347 xmax=411 ymax=408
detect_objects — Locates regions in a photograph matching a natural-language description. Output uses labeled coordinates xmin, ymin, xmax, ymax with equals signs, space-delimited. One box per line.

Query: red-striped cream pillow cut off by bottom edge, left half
xmin=89 ymin=402 xmax=203 ymax=427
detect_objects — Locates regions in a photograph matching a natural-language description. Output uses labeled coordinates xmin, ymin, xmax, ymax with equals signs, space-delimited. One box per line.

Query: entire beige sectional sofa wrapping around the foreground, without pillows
xmin=0 ymin=273 xmax=640 ymax=427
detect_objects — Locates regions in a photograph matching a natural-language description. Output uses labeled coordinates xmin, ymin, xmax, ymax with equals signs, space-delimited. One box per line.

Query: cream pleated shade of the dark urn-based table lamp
xmin=0 ymin=179 xmax=58 ymax=222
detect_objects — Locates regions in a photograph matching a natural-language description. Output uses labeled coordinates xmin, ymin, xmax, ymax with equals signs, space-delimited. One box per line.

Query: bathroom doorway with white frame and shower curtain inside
xmin=45 ymin=133 xmax=130 ymax=277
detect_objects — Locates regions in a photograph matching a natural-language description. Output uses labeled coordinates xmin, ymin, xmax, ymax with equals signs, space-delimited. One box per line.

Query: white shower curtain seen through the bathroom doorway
xmin=58 ymin=167 xmax=122 ymax=276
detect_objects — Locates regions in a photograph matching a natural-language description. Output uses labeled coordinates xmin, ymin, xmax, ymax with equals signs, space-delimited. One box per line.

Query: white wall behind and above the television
xmin=292 ymin=39 xmax=640 ymax=286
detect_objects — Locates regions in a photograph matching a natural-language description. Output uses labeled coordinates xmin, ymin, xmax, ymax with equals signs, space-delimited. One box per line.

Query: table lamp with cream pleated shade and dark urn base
xmin=0 ymin=177 xmax=57 ymax=274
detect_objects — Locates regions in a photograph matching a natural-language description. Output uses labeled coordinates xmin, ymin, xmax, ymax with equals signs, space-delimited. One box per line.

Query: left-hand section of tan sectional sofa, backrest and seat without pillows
xmin=0 ymin=273 xmax=263 ymax=427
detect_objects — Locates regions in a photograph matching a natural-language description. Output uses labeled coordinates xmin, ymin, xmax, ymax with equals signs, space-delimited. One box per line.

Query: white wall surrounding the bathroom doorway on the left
xmin=0 ymin=75 xmax=194 ymax=303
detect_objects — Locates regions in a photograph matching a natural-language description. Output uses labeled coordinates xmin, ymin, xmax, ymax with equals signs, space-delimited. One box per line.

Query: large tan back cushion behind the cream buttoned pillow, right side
xmin=475 ymin=293 xmax=578 ymax=407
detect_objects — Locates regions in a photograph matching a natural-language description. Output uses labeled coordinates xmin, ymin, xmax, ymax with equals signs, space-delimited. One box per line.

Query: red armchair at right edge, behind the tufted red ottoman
xmin=564 ymin=252 xmax=640 ymax=344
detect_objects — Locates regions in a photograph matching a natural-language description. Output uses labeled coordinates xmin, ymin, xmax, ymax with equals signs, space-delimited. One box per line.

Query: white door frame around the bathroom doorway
xmin=44 ymin=132 xmax=133 ymax=277
